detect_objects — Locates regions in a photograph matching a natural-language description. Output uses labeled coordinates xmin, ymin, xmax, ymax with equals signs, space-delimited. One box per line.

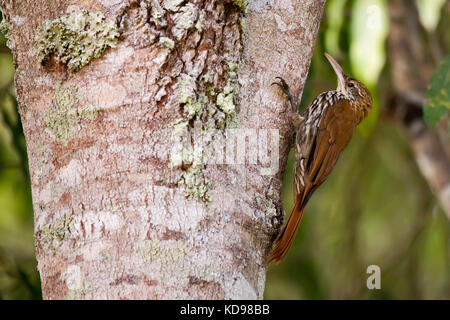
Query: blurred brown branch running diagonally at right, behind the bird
xmin=388 ymin=0 xmax=450 ymax=218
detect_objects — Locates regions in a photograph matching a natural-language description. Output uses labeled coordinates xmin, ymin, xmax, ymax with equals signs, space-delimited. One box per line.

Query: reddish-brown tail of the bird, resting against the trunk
xmin=269 ymin=194 xmax=305 ymax=262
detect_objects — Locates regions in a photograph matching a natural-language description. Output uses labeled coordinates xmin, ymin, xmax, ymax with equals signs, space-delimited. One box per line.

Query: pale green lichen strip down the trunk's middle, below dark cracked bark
xmin=168 ymin=59 xmax=243 ymax=204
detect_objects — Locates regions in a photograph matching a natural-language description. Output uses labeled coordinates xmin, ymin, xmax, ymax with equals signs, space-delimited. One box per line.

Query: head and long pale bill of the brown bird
xmin=325 ymin=53 xmax=372 ymax=113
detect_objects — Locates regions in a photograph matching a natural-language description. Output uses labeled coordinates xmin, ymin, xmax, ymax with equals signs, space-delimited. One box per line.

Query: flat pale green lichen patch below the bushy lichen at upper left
xmin=44 ymin=82 xmax=98 ymax=145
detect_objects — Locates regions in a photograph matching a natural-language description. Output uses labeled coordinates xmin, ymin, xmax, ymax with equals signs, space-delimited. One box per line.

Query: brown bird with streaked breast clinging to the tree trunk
xmin=269 ymin=53 xmax=372 ymax=262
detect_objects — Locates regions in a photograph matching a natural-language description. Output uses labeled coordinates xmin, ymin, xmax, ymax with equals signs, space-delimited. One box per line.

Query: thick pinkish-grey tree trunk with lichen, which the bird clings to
xmin=2 ymin=0 xmax=324 ymax=299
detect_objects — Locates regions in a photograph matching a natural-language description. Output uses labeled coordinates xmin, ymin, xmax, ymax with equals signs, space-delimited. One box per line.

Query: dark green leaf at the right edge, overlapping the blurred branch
xmin=423 ymin=56 xmax=450 ymax=129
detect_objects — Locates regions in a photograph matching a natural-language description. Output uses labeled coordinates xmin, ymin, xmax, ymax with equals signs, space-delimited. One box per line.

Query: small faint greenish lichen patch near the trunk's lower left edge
xmin=40 ymin=212 xmax=73 ymax=248
